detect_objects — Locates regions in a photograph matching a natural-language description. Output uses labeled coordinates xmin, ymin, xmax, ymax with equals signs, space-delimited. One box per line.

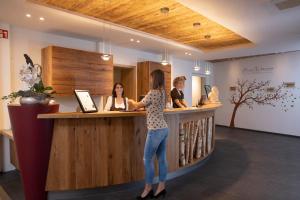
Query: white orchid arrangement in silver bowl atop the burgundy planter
xmin=2 ymin=54 xmax=54 ymax=105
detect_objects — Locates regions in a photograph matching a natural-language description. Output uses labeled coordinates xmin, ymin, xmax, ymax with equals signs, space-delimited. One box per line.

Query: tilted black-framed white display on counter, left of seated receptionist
xmin=74 ymin=90 xmax=98 ymax=113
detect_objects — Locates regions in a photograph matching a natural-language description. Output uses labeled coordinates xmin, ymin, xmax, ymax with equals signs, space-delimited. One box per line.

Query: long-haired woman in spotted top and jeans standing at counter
xmin=129 ymin=70 xmax=169 ymax=199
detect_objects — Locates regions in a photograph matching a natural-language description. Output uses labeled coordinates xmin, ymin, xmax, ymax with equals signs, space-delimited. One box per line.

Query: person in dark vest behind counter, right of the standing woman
xmin=171 ymin=76 xmax=187 ymax=108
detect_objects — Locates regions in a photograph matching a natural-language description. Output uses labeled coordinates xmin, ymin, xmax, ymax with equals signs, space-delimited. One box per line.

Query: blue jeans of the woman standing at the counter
xmin=144 ymin=128 xmax=169 ymax=184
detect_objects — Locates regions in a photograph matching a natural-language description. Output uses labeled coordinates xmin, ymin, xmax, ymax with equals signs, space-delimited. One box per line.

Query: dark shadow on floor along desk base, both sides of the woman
xmin=50 ymin=139 xmax=248 ymax=200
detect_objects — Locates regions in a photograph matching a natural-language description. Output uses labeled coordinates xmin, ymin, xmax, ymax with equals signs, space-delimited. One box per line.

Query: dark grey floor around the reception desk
xmin=0 ymin=127 xmax=300 ymax=200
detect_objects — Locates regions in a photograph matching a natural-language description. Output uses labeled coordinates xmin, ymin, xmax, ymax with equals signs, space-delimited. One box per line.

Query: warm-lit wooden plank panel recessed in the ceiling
xmin=30 ymin=0 xmax=251 ymax=51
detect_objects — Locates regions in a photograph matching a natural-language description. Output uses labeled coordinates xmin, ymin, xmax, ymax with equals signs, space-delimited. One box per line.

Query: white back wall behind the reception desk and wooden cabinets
xmin=0 ymin=23 xmax=216 ymax=171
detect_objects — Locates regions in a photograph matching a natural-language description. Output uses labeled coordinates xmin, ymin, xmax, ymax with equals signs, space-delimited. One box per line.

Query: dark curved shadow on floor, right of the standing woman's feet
xmin=163 ymin=139 xmax=249 ymax=199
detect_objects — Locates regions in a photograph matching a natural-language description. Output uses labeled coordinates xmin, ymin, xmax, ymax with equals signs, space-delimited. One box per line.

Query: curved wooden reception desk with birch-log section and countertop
xmin=38 ymin=104 xmax=220 ymax=191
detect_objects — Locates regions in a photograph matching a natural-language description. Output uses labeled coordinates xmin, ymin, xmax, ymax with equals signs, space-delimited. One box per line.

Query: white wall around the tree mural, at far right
xmin=214 ymin=52 xmax=300 ymax=136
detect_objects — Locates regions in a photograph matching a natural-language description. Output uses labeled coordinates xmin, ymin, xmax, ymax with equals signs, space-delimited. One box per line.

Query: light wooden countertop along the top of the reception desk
xmin=38 ymin=104 xmax=222 ymax=119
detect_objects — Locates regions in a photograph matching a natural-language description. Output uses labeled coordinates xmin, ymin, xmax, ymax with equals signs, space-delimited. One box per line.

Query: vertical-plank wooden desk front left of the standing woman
xmin=46 ymin=118 xmax=134 ymax=190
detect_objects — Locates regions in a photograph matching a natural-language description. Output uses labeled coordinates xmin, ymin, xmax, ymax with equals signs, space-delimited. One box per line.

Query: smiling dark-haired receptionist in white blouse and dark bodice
xmin=104 ymin=83 xmax=128 ymax=111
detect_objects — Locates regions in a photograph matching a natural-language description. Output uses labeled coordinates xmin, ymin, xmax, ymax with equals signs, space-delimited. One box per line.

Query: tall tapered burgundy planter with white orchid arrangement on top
xmin=2 ymin=54 xmax=59 ymax=200
